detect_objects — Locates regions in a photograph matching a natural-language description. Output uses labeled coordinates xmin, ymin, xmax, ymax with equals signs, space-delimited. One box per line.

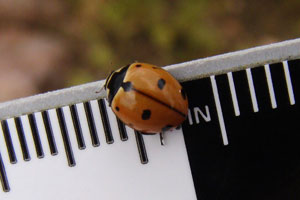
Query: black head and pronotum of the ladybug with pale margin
xmin=104 ymin=64 xmax=131 ymax=106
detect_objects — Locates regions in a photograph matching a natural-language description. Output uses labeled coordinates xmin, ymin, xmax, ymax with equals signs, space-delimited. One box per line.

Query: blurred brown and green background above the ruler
xmin=0 ymin=0 xmax=300 ymax=102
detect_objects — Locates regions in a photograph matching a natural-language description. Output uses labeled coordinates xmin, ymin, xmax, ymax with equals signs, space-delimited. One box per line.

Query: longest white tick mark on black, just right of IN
xmin=210 ymin=76 xmax=228 ymax=145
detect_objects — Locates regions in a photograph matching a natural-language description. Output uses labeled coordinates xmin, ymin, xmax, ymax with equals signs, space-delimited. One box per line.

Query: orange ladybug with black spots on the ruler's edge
xmin=104 ymin=63 xmax=188 ymax=134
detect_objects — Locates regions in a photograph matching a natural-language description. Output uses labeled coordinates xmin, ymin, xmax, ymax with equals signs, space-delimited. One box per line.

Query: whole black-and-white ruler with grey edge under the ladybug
xmin=0 ymin=39 xmax=300 ymax=200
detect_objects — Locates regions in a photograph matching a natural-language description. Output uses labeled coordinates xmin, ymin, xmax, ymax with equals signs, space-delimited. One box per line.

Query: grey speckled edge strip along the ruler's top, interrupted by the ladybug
xmin=0 ymin=38 xmax=300 ymax=120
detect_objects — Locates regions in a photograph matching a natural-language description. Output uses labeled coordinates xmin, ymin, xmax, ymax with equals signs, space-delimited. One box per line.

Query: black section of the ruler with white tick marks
xmin=183 ymin=60 xmax=300 ymax=200
